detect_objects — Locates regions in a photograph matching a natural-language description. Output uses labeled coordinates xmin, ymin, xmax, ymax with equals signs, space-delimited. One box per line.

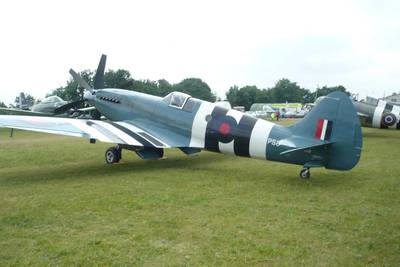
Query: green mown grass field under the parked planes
xmin=0 ymin=122 xmax=400 ymax=266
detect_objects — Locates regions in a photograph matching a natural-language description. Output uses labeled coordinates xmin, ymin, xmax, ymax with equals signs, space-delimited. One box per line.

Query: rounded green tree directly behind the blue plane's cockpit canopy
xmin=173 ymin=78 xmax=216 ymax=102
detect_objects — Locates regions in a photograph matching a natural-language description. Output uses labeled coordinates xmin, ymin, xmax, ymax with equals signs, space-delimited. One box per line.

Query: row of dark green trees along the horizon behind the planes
xmin=0 ymin=69 xmax=350 ymax=110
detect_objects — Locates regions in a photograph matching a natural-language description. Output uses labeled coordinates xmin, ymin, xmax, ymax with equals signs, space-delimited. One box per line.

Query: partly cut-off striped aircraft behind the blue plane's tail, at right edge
xmin=353 ymin=97 xmax=400 ymax=129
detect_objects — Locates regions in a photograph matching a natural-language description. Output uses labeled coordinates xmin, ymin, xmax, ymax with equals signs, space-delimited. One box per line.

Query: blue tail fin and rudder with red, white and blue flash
xmin=289 ymin=92 xmax=362 ymax=170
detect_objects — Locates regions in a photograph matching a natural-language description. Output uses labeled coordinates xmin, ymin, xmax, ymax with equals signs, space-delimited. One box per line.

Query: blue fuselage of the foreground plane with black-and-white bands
xmin=92 ymin=89 xmax=358 ymax=169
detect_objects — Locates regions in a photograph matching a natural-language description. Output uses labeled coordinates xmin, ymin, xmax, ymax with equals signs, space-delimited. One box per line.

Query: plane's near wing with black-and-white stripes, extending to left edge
xmin=0 ymin=115 xmax=170 ymax=148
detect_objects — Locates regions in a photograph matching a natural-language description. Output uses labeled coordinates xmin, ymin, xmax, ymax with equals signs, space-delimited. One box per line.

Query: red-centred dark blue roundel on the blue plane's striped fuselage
xmin=209 ymin=116 xmax=237 ymax=143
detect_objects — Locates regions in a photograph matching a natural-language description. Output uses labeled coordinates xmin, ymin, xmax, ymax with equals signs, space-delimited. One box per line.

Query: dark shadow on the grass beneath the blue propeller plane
xmin=0 ymin=154 xmax=354 ymax=191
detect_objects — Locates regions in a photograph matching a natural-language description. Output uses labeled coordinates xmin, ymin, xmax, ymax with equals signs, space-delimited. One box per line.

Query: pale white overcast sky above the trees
xmin=0 ymin=0 xmax=400 ymax=103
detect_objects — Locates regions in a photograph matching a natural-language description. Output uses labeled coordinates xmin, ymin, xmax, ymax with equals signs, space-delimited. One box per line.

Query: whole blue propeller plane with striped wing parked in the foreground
xmin=0 ymin=55 xmax=362 ymax=178
